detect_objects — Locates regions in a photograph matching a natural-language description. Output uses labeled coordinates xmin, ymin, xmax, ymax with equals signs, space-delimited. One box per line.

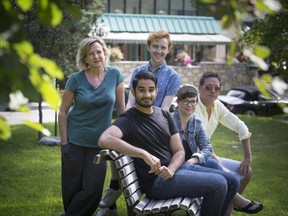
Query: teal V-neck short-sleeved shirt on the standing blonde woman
xmin=65 ymin=67 xmax=124 ymax=148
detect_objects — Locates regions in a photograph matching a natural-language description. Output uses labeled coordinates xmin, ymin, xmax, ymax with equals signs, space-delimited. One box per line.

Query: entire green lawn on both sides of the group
xmin=0 ymin=116 xmax=288 ymax=216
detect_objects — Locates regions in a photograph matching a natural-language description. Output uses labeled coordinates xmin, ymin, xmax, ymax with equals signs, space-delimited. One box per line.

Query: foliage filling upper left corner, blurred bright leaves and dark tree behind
xmin=0 ymin=0 xmax=103 ymax=140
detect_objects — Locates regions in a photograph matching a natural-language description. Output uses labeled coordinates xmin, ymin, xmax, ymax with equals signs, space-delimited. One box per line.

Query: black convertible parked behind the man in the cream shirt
xmin=218 ymin=86 xmax=288 ymax=116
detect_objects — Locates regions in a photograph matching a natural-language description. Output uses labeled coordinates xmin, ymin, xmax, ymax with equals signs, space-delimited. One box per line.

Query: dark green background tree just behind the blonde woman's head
xmin=24 ymin=0 xmax=103 ymax=75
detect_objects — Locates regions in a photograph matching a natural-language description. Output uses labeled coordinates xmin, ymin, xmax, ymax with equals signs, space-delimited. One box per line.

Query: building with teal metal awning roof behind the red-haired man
xmin=93 ymin=0 xmax=231 ymax=65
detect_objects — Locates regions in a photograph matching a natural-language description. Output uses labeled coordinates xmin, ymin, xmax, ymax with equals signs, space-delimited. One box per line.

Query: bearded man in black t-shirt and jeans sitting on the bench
xmin=99 ymin=71 xmax=239 ymax=216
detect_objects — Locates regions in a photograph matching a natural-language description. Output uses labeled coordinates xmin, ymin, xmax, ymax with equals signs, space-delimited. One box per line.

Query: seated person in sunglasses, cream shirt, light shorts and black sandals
xmin=195 ymin=72 xmax=263 ymax=216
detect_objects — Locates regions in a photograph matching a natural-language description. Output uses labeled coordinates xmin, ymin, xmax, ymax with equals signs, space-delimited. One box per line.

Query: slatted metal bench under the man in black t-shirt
xmin=94 ymin=149 xmax=202 ymax=216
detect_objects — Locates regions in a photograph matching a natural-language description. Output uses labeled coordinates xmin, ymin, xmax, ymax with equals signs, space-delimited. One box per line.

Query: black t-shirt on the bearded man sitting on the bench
xmin=113 ymin=107 xmax=178 ymax=192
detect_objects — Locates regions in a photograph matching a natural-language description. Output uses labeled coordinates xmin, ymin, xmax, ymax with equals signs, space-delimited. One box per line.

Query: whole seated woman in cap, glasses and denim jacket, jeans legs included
xmin=173 ymin=84 xmax=239 ymax=215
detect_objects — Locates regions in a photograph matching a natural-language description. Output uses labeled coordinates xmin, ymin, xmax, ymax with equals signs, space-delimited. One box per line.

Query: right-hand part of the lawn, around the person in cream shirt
xmin=211 ymin=116 xmax=288 ymax=216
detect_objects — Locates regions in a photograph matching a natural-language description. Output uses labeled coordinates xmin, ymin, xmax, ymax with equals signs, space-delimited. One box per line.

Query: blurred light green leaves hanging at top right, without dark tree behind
xmin=198 ymin=0 xmax=281 ymax=66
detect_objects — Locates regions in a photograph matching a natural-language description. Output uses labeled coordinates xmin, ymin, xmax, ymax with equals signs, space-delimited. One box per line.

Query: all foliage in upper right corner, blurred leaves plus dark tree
xmin=198 ymin=0 xmax=288 ymax=107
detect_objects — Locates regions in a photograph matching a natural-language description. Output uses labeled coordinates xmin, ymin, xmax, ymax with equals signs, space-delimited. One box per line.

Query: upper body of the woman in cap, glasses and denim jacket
xmin=173 ymin=84 xmax=221 ymax=169
